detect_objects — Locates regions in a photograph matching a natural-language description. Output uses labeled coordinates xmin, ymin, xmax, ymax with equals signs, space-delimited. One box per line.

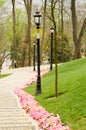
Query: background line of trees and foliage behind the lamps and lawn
xmin=0 ymin=0 xmax=86 ymax=68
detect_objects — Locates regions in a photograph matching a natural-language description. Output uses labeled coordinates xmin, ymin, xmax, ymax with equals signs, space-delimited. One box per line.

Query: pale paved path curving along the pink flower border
xmin=0 ymin=66 xmax=49 ymax=130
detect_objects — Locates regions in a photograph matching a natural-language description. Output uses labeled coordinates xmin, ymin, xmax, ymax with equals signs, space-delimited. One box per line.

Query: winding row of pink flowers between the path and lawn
xmin=14 ymin=71 xmax=70 ymax=130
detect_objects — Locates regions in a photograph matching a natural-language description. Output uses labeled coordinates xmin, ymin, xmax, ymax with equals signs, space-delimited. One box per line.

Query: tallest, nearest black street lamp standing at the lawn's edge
xmin=34 ymin=11 xmax=42 ymax=95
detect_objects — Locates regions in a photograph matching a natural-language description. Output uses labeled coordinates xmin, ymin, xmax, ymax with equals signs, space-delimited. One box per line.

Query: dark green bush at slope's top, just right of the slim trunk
xmin=53 ymin=34 xmax=72 ymax=62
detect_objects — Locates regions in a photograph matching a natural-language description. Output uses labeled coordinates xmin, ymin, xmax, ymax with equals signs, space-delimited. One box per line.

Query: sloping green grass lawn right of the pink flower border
xmin=25 ymin=59 xmax=86 ymax=130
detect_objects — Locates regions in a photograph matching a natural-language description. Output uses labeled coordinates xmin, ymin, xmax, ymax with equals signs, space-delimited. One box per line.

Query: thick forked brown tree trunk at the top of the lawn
xmin=71 ymin=0 xmax=86 ymax=59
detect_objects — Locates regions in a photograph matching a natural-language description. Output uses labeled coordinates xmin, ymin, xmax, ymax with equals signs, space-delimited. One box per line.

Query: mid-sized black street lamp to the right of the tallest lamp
xmin=50 ymin=27 xmax=54 ymax=71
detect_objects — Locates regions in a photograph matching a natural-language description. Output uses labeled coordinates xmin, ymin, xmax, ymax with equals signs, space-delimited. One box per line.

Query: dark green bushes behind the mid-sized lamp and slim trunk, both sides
xmin=43 ymin=34 xmax=72 ymax=63
